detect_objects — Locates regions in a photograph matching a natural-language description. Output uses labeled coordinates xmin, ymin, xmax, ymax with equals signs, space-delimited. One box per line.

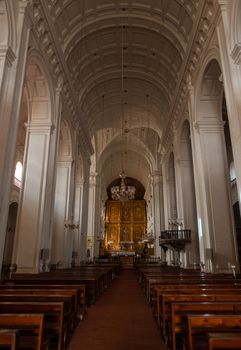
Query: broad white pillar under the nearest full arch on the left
xmin=14 ymin=121 xmax=55 ymax=273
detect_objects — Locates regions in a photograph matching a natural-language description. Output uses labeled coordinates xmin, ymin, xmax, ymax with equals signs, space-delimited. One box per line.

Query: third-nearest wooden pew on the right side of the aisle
xmin=167 ymin=302 xmax=241 ymax=350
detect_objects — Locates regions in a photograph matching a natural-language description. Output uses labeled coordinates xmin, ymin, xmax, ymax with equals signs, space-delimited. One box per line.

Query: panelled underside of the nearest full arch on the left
xmin=26 ymin=49 xmax=56 ymax=123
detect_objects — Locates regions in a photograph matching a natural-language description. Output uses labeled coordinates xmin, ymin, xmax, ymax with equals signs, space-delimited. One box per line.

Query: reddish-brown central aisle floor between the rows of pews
xmin=68 ymin=270 xmax=165 ymax=350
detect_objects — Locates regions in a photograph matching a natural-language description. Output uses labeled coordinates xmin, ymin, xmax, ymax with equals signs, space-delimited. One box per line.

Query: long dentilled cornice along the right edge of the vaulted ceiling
xmin=162 ymin=0 xmax=219 ymax=149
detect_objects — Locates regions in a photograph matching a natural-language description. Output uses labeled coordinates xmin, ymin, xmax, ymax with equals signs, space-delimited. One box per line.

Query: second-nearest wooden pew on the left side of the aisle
xmin=0 ymin=314 xmax=45 ymax=350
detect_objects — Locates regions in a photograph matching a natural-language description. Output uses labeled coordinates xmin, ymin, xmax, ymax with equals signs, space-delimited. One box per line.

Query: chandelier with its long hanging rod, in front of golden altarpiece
xmin=111 ymin=25 xmax=136 ymax=201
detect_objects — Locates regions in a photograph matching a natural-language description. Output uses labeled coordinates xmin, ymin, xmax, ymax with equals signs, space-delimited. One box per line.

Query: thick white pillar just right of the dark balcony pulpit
xmin=193 ymin=120 xmax=237 ymax=270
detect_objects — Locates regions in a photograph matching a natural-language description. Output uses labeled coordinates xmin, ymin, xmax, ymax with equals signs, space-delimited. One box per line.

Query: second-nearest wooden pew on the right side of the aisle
xmin=185 ymin=315 xmax=241 ymax=350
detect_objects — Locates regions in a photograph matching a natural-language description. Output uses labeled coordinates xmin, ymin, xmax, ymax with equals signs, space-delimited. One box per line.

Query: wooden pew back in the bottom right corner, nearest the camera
xmin=207 ymin=332 xmax=241 ymax=350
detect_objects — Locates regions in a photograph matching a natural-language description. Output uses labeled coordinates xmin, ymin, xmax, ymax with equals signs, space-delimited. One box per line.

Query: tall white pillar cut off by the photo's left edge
xmin=0 ymin=2 xmax=30 ymax=266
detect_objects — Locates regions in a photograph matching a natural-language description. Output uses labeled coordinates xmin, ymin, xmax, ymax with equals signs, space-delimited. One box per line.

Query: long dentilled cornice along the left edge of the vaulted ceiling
xmin=27 ymin=0 xmax=93 ymax=154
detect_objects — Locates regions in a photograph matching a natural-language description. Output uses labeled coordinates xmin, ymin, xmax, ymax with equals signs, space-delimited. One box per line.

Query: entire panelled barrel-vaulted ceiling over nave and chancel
xmin=37 ymin=0 xmax=213 ymax=189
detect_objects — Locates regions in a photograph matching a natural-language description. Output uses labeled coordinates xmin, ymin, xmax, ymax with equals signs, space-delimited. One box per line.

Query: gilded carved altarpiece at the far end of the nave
xmin=105 ymin=200 xmax=146 ymax=254
